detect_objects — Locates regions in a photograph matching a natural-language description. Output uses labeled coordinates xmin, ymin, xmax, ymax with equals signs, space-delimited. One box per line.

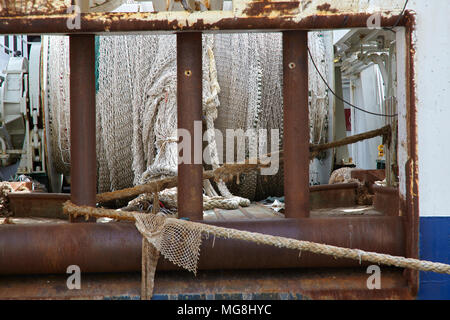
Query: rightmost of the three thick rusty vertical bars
xmin=283 ymin=31 xmax=309 ymax=218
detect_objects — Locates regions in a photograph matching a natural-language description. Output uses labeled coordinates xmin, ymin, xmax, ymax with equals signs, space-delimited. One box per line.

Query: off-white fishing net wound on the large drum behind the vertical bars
xmin=47 ymin=32 xmax=328 ymax=199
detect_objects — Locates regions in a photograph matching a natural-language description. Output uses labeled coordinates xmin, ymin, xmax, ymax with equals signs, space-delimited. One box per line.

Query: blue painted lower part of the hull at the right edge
xmin=417 ymin=217 xmax=450 ymax=300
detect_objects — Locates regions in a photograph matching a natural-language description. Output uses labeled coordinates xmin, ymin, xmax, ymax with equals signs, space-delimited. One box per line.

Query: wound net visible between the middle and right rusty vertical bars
xmin=214 ymin=33 xmax=283 ymax=200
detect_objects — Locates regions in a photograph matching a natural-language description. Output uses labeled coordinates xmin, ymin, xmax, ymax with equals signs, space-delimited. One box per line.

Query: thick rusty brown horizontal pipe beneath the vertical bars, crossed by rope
xmin=0 ymin=217 xmax=405 ymax=275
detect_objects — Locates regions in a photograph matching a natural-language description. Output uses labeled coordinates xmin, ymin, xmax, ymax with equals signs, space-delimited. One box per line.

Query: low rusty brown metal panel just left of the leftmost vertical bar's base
xmin=8 ymin=192 xmax=70 ymax=219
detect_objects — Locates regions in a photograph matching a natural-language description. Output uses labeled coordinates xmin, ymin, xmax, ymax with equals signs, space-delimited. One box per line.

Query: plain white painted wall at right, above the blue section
xmin=408 ymin=0 xmax=450 ymax=216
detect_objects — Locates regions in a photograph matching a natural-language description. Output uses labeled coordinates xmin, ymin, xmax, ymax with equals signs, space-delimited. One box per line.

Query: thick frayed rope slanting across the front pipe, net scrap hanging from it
xmin=63 ymin=201 xmax=450 ymax=299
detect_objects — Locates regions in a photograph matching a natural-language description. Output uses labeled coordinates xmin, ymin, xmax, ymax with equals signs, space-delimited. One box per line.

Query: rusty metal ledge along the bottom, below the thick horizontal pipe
xmin=0 ymin=267 xmax=413 ymax=300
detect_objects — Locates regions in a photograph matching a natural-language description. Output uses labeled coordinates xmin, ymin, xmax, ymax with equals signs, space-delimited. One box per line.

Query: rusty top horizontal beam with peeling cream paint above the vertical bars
xmin=0 ymin=12 xmax=407 ymax=34
